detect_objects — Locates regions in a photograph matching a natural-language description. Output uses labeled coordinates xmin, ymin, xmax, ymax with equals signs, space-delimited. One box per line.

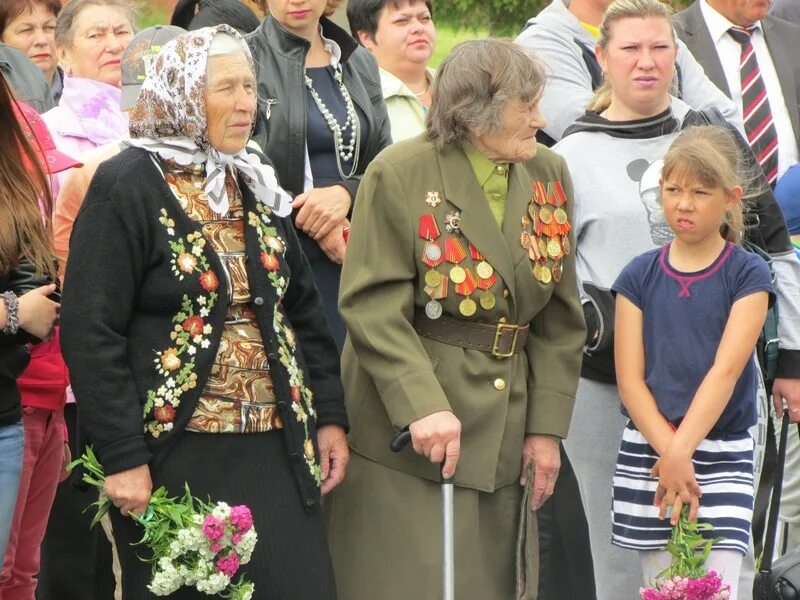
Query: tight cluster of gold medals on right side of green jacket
xmin=520 ymin=181 xmax=571 ymax=285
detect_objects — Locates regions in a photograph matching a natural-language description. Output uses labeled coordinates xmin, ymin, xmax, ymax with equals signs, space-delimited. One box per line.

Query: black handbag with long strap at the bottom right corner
xmin=753 ymin=412 xmax=800 ymax=600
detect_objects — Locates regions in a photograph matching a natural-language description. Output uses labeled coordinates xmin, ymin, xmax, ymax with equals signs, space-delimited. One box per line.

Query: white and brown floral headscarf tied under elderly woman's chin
xmin=126 ymin=25 xmax=292 ymax=216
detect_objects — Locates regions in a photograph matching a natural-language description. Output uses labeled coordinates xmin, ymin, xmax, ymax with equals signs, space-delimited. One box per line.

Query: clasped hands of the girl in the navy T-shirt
xmin=650 ymin=451 xmax=702 ymax=525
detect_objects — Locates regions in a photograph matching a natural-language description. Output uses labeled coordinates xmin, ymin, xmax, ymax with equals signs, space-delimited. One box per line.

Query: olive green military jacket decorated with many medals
xmin=339 ymin=136 xmax=585 ymax=492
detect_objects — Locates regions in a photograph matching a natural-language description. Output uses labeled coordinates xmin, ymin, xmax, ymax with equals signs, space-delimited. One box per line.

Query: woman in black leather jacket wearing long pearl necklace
xmin=247 ymin=0 xmax=391 ymax=349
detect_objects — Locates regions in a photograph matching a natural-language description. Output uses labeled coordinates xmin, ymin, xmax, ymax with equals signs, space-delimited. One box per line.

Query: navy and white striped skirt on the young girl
xmin=611 ymin=421 xmax=754 ymax=554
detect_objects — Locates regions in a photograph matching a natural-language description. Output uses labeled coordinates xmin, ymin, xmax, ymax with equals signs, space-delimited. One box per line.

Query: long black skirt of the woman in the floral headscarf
xmin=111 ymin=431 xmax=336 ymax=600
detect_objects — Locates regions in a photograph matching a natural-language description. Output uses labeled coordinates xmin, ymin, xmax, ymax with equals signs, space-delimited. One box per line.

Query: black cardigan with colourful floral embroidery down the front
xmin=61 ymin=148 xmax=348 ymax=508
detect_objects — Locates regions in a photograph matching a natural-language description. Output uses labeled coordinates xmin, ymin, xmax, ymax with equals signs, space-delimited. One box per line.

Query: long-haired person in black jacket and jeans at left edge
xmin=0 ymin=72 xmax=58 ymax=556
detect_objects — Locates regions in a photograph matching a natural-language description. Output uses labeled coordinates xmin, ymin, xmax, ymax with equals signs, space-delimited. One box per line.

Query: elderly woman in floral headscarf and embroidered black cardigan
xmin=62 ymin=25 xmax=348 ymax=600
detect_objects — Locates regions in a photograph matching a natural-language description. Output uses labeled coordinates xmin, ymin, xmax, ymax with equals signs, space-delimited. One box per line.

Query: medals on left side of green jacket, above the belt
xmin=419 ymin=213 xmax=497 ymax=319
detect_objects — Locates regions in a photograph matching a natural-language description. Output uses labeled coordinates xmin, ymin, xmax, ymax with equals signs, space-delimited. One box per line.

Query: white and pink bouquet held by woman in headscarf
xmin=69 ymin=448 xmax=258 ymax=600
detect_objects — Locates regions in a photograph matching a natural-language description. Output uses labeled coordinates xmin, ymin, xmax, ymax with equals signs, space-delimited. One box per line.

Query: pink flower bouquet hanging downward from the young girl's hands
xmin=639 ymin=507 xmax=730 ymax=600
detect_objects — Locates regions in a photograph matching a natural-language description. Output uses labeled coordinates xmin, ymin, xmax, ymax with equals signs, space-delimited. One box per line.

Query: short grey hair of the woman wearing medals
xmin=427 ymin=39 xmax=546 ymax=150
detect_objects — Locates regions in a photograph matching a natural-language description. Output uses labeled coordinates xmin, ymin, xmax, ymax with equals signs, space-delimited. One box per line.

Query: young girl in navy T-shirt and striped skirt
xmin=612 ymin=127 xmax=773 ymax=598
